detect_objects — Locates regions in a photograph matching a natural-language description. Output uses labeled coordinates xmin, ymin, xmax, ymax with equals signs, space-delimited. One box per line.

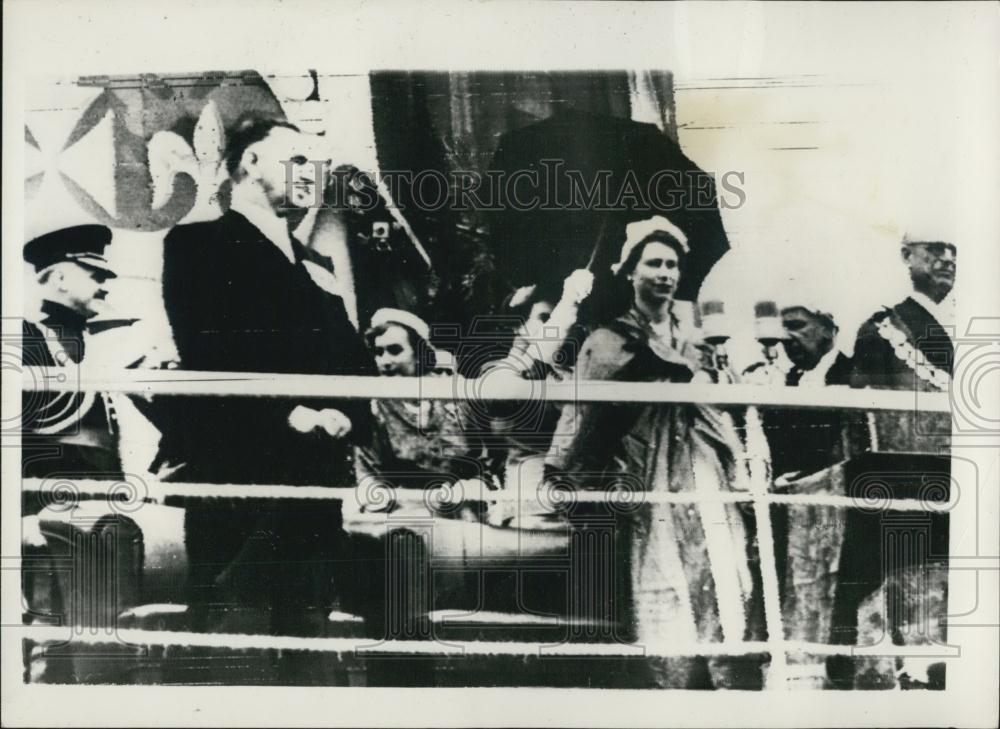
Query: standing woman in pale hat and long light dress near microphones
xmin=546 ymin=216 xmax=751 ymax=688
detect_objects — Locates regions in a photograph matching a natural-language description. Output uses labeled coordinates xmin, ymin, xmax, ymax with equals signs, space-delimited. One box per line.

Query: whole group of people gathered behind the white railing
xmin=23 ymin=116 xmax=956 ymax=687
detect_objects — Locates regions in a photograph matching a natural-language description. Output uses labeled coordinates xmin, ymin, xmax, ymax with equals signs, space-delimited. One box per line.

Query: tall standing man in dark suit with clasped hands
xmin=156 ymin=120 xmax=375 ymax=633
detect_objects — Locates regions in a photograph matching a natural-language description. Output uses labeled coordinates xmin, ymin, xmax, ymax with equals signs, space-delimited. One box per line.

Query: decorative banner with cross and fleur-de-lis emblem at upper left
xmin=25 ymin=71 xmax=285 ymax=234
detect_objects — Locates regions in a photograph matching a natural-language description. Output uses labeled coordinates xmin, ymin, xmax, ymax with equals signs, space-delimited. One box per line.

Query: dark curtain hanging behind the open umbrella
xmin=371 ymin=71 xmax=652 ymax=324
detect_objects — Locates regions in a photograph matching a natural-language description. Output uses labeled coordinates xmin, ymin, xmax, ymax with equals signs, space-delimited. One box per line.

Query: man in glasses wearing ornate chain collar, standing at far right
xmin=844 ymin=234 xmax=958 ymax=688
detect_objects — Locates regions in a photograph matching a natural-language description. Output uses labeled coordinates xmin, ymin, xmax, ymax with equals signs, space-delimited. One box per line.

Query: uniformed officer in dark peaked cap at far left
xmin=21 ymin=225 xmax=121 ymax=478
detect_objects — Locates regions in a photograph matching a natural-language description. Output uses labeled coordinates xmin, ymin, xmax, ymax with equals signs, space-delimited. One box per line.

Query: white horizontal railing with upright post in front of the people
xmin=15 ymin=367 xmax=954 ymax=687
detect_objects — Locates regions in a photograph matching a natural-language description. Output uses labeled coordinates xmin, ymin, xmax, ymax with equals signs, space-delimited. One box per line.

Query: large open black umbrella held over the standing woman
xmin=487 ymin=110 xmax=729 ymax=309
